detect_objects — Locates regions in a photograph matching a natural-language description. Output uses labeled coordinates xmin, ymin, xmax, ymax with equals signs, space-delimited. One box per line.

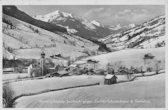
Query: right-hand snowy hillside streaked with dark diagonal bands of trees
xmin=99 ymin=16 xmax=165 ymax=50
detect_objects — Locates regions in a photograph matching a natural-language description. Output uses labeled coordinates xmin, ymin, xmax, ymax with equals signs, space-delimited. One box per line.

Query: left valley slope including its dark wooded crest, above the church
xmin=2 ymin=6 xmax=111 ymax=64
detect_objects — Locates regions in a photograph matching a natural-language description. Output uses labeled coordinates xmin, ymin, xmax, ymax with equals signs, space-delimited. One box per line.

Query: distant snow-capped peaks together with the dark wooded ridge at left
xmin=3 ymin=6 xmax=140 ymax=40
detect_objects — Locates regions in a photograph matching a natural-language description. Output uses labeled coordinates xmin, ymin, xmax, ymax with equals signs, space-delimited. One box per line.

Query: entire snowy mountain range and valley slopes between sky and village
xmin=3 ymin=6 xmax=165 ymax=61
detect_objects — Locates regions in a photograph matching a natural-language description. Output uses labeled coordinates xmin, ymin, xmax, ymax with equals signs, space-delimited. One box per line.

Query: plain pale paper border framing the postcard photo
xmin=0 ymin=0 xmax=168 ymax=110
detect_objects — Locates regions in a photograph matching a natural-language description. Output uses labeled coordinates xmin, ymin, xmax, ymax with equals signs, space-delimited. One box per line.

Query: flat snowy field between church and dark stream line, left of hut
xmin=11 ymin=75 xmax=104 ymax=96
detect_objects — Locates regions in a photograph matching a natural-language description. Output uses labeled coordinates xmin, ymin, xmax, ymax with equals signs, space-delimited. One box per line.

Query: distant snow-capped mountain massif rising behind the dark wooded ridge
xmin=32 ymin=10 xmax=113 ymax=39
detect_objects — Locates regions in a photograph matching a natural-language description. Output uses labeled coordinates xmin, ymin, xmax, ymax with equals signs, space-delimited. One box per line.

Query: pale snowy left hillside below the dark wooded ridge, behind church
xmin=3 ymin=14 xmax=98 ymax=60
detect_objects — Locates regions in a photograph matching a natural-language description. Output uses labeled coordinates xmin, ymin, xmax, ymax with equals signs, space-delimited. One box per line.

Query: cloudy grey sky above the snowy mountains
xmin=17 ymin=5 xmax=165 ymax=25
